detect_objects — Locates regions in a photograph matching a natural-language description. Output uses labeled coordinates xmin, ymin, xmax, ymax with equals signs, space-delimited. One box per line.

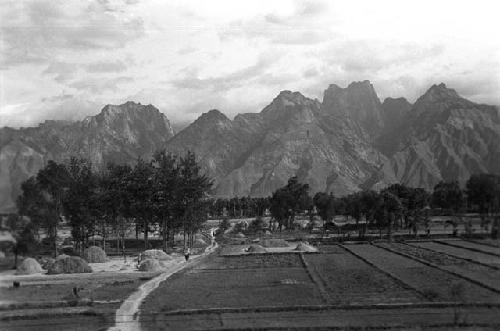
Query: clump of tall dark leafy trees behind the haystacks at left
xmin=17 ymin=151 xmax=213 ymax=255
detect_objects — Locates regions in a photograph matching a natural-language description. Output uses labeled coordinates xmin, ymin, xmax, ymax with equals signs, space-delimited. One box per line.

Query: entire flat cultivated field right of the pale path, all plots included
xmin=140 ymin=241 xmax=500 ymax=330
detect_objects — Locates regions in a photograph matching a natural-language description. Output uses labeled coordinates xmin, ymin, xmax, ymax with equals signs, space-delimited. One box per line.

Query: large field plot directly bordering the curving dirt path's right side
xmin=141 ymin=254 xmax=323 ymax=312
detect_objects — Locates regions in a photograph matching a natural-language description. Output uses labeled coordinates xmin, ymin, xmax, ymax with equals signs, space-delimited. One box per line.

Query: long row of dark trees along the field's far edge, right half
xmin=270 ymin=174 xmax=500 ymax=238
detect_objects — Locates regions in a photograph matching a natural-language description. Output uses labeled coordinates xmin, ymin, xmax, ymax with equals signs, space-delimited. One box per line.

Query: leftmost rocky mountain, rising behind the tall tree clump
xmin=0 ymin=102 xmax=174 ymax=212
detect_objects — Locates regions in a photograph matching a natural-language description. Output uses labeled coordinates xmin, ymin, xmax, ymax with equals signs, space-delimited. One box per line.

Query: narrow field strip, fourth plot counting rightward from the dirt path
xmin=378 ymin=243 xmax=500 ymax=293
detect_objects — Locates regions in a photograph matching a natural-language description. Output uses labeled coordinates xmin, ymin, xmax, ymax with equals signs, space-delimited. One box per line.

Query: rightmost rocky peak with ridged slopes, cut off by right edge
xmin=390 ymin=84 xmax=500 ymax=189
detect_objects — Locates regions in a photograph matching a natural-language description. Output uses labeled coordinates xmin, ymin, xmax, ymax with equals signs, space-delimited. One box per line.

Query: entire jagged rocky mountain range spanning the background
xmin=0 ymin=81 xmax=500 ymax=212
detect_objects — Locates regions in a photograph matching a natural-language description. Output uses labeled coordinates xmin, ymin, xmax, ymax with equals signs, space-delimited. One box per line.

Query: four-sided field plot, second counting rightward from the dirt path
xmin=305 ymin=246 xmax=422 ymax=304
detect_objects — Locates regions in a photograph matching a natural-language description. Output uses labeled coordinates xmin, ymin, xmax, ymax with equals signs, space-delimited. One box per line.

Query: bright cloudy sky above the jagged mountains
xmin=0 ymin=0 xmax=500 ymax=127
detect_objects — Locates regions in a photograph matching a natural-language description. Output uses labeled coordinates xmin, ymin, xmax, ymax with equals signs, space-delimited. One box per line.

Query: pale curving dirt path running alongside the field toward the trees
xmin=108 ymin=243 xmax=217 ymax=331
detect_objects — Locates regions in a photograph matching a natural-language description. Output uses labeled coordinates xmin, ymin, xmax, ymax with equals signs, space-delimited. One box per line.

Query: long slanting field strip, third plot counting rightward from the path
xmin=346 ymin=244 xmax=499 ymax=302
